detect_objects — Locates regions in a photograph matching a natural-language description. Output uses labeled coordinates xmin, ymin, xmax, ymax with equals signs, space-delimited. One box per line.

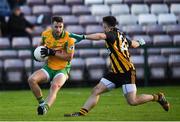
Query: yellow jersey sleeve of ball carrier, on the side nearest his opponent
xmin=66 ymin=38 xmax=75 ymax=53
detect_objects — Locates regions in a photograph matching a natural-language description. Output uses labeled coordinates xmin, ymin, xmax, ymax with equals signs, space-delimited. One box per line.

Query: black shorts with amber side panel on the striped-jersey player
xmin=103 ymin=70 xmax=136 ymax=88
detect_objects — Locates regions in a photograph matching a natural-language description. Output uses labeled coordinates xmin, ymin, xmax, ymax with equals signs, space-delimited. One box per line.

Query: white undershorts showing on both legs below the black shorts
xmin=100 ymin=78 xmax=137 ymax=94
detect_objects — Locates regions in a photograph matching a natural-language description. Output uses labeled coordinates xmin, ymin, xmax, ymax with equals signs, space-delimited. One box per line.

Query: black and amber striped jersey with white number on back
xmin=105 ymin=28 xmax=135 ymax=73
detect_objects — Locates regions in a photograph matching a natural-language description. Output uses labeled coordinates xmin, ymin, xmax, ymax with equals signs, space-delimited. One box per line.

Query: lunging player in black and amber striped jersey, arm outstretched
xmin=64 ymin=16 xmax=170 ymax=117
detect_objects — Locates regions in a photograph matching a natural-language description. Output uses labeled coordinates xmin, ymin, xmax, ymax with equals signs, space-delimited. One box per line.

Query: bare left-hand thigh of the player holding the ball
xmin=29 ymin=69 xmax=48 ymax=83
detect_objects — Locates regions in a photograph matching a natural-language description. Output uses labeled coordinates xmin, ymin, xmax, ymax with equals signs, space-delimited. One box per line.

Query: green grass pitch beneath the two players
xmin=0 ymin=86 xmax=180 ymax=121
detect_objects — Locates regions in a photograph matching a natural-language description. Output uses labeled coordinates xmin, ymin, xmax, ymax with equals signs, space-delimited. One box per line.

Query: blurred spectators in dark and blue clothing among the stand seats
xmin=0 ymin=0 xmax=34 ymax=39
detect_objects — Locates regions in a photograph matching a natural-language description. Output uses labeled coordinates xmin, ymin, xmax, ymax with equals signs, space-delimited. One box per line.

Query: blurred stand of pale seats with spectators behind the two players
xmin=0 ymin=0 xmax=180 ymax=90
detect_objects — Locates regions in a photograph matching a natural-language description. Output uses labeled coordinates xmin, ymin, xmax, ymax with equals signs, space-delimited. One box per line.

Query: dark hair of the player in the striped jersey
xmin=103 ymin=16 xmax=118 ymax=27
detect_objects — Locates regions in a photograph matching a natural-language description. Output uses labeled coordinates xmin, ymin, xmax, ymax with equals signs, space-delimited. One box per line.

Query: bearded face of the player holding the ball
xmin=53 ymin=21 xmax=64 ymax=35
